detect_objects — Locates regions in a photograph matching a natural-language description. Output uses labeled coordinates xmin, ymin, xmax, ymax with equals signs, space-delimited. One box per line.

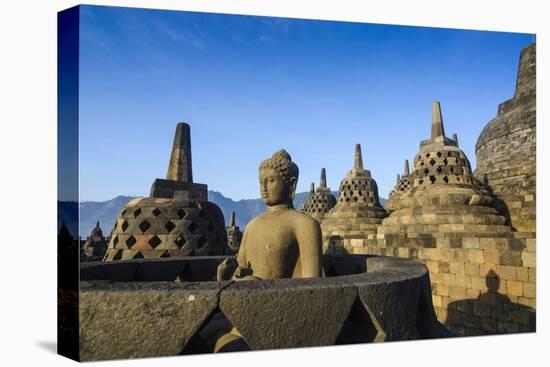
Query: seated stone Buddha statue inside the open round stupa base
xmin=218 ymin=150 xmax=322 ymax=280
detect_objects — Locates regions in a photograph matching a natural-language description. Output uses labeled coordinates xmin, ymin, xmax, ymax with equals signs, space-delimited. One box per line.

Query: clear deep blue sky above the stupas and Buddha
xmin=80 ymin=6 xmax=535 ymax=200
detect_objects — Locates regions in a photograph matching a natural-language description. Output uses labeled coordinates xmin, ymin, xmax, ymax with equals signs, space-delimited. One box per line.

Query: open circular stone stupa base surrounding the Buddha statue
xmin=80 ymin=255 xmax=450 ymax=361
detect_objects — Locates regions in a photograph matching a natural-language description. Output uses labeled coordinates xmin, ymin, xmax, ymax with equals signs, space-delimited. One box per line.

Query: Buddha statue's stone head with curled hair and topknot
xmin=260 ymin=149 xmax=298 ymax=206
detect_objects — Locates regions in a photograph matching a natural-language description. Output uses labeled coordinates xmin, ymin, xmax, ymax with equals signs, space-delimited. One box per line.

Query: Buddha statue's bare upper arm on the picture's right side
xmin=296 ymin=218 xmax=322 ymax=278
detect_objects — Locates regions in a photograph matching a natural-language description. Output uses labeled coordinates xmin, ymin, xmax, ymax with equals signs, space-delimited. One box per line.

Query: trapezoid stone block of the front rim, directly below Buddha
xmin=220 ymin=278 xmax=357 ymax=349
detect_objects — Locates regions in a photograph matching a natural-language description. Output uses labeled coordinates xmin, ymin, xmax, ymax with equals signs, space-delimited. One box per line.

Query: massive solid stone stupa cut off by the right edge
xmin=474 ymin=43 xmax=537 ymax=232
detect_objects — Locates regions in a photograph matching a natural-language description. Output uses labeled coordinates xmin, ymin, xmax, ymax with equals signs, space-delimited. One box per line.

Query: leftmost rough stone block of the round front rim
xmin=80 ymin=281 xmax=228 ymax=361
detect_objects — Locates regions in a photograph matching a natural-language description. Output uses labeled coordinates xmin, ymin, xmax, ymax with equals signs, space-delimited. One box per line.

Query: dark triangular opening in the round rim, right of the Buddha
xmin=336 ymin=297 xmax=385 ymax=345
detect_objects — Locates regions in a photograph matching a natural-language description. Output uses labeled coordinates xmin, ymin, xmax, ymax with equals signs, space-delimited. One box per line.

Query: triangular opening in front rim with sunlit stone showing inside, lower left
xmin=180 ymin=308 xmax=250 ymax=354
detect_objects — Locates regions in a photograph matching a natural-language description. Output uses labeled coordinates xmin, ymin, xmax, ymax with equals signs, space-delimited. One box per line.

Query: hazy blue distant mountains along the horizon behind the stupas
xmin=57 ymin=191 xmax=386 ymax=238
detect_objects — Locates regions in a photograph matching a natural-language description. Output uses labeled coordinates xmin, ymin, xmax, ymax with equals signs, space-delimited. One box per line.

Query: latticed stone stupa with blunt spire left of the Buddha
xmin=104 ymin=123 xmax=227 ymax=261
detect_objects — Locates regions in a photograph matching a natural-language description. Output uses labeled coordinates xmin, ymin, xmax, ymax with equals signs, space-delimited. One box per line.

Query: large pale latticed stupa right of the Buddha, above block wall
xmin=379 ymin=102 xmax=511 ymax=237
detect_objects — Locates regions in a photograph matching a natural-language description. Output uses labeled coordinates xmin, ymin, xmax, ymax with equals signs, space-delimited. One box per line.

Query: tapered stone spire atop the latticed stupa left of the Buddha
xmin=166 ymin=122 xmax=193 ymax=183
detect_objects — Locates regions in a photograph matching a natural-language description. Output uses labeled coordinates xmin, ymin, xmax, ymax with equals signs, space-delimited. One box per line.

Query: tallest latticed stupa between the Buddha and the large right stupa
xmin=321 ymin=144 xmax=388 ymax=252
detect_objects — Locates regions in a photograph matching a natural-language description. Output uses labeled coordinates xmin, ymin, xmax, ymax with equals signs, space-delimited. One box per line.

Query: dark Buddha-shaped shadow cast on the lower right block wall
xmin=445 ymin=269 xmax=536 ymax=336
